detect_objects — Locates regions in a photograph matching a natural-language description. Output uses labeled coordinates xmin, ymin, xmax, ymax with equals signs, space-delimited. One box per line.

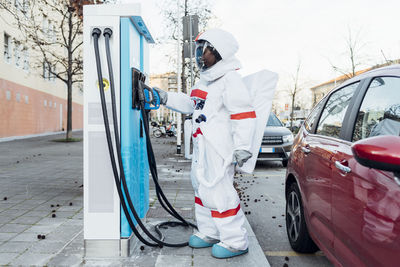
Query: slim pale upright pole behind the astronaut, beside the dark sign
xmin=176 ymin=0 xmax=182 ymax=154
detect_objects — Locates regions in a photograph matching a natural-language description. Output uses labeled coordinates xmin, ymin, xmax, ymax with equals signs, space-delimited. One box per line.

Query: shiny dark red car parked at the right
xmin=285 ymin=65 xmax=400 ymax=266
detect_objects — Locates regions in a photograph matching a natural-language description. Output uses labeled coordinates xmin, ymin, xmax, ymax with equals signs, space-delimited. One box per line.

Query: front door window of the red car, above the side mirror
xmin=352 ymin=77 xmax=400 ymax=142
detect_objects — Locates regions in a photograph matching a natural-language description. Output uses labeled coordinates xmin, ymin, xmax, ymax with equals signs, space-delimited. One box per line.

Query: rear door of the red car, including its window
xmin=302 ymin=82 xmax=359 ymax=258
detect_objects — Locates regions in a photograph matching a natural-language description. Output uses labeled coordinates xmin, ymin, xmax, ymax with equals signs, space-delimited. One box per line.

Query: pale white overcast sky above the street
xmin=124 ymin=0 xmax=400 ymax=109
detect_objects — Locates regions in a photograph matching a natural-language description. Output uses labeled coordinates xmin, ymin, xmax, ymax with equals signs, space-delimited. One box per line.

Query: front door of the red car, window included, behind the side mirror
xmin=332 ymin=77 xmax=400 ymax=266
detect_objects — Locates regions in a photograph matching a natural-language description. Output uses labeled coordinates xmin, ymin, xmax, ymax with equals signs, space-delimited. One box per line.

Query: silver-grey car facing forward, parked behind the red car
xmin=258 ymin=112 xmax=293 ymax=167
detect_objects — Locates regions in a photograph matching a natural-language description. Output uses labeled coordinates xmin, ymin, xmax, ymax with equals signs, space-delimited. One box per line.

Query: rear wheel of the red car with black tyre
xmin=286 ymin=183 xmax=319 ymax=253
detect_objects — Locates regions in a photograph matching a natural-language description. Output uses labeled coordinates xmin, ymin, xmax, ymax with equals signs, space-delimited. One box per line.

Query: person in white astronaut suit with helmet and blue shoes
xmin=156 ymin=29 xmax=278 ymax=258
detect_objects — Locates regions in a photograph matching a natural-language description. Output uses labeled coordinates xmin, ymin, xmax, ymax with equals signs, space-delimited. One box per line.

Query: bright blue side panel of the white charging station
xmin=120 ymin=18 xmax=149 ymax=238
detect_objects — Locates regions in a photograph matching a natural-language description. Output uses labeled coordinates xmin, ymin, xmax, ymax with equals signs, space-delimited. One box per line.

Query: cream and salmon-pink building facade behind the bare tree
xmin=0 ymin=0 xmax=83 ymax=138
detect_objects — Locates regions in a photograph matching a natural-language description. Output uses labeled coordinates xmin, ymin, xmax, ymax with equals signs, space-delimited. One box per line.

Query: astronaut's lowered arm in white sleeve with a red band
xmin=223 ymin=72 xmax=256 ymax=163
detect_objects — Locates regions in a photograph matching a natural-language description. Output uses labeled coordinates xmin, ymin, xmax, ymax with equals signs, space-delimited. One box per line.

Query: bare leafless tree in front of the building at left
xmin=0 ymin=0 xmax=102 ymax=139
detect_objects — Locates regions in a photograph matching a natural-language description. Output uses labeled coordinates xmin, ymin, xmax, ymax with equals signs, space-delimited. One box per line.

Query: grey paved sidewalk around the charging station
xmin=0 ymin=132 xmax=269 ymax=266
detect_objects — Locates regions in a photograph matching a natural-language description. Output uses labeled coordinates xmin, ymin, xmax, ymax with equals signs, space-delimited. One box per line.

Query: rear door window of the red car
xmin=317 ymin=82 xmax=359 ymax=138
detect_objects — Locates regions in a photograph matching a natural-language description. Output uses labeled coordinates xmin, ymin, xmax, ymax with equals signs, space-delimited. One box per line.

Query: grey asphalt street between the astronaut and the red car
xmin=235 ymin=161 xmax=332 ymax=267
